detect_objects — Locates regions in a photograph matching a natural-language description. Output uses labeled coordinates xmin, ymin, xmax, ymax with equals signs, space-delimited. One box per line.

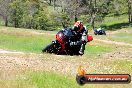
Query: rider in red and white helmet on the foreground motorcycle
xmin=70 ymin=21 xmax=87 ymax=55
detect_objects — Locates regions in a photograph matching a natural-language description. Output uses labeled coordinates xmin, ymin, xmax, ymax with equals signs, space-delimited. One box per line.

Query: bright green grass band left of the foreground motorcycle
xmin=0 ymin=34 xmax=50 ymax=52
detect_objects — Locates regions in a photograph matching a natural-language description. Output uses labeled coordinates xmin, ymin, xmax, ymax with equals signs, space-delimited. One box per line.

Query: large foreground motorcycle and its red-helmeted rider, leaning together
xmin=42 ymin=21 xmax=89 ymax=55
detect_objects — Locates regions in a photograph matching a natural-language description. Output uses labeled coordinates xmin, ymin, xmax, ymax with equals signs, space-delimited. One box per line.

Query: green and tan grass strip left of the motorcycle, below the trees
xmin=0 ymin=26 xmax=54 ymax=53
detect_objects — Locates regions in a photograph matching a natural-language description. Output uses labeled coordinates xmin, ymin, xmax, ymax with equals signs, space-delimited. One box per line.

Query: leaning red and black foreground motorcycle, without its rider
xmin=42 ymin=29 xmax=93 ymax=55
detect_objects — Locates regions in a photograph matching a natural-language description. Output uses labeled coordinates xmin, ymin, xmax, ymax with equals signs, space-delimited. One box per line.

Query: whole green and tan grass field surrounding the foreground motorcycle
xmin=0 ymin=27 xmax=132 ymax=88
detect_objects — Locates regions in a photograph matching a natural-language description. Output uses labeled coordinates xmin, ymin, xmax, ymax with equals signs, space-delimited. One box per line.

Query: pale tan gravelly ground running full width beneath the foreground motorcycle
xmin=0 ymin=42 xmax=132 ymax=88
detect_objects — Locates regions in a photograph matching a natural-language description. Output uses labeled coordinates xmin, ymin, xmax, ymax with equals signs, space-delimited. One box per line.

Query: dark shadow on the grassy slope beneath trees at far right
xmin=104 ymin=23 xmax=132 ymax=31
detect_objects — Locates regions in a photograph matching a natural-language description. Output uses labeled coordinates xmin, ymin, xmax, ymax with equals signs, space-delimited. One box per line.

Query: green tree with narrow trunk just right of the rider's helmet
xmin=83 ymin=0 xmax=112 ymax=29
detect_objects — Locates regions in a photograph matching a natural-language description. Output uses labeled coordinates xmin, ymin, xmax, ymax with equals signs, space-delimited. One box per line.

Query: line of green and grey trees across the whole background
xmin=0 ymin=0 xmax=132 ymax=30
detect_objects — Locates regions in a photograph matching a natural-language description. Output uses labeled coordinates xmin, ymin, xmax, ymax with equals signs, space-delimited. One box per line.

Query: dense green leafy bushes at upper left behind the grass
xmin=10 ymin=0 xmax=48 ymax=30
